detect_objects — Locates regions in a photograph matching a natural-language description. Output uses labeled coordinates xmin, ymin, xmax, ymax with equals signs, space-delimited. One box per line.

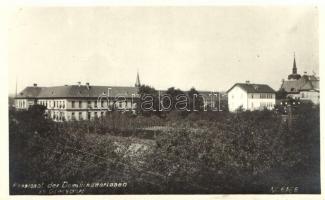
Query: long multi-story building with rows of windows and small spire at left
xmin=15 ymin=73 xmax=140 ymax=121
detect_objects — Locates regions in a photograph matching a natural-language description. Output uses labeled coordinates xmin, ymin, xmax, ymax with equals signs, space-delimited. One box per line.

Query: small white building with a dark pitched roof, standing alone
xmin=227 ymin=81 xmax=275 ymax=112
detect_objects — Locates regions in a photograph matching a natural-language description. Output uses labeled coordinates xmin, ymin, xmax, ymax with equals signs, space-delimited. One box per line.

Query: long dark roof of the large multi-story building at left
xmin=17 ymin=85 xmax=138 ymax=98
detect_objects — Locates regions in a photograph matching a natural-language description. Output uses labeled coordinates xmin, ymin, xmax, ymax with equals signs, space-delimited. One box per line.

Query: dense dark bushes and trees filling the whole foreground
xmin=9 ymin=104 xmax=320 ymax=194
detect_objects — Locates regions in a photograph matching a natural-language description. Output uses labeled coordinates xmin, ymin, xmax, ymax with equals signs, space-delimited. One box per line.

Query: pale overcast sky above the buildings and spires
xmin=8 ymin=7 xmax=319 ymax=93
